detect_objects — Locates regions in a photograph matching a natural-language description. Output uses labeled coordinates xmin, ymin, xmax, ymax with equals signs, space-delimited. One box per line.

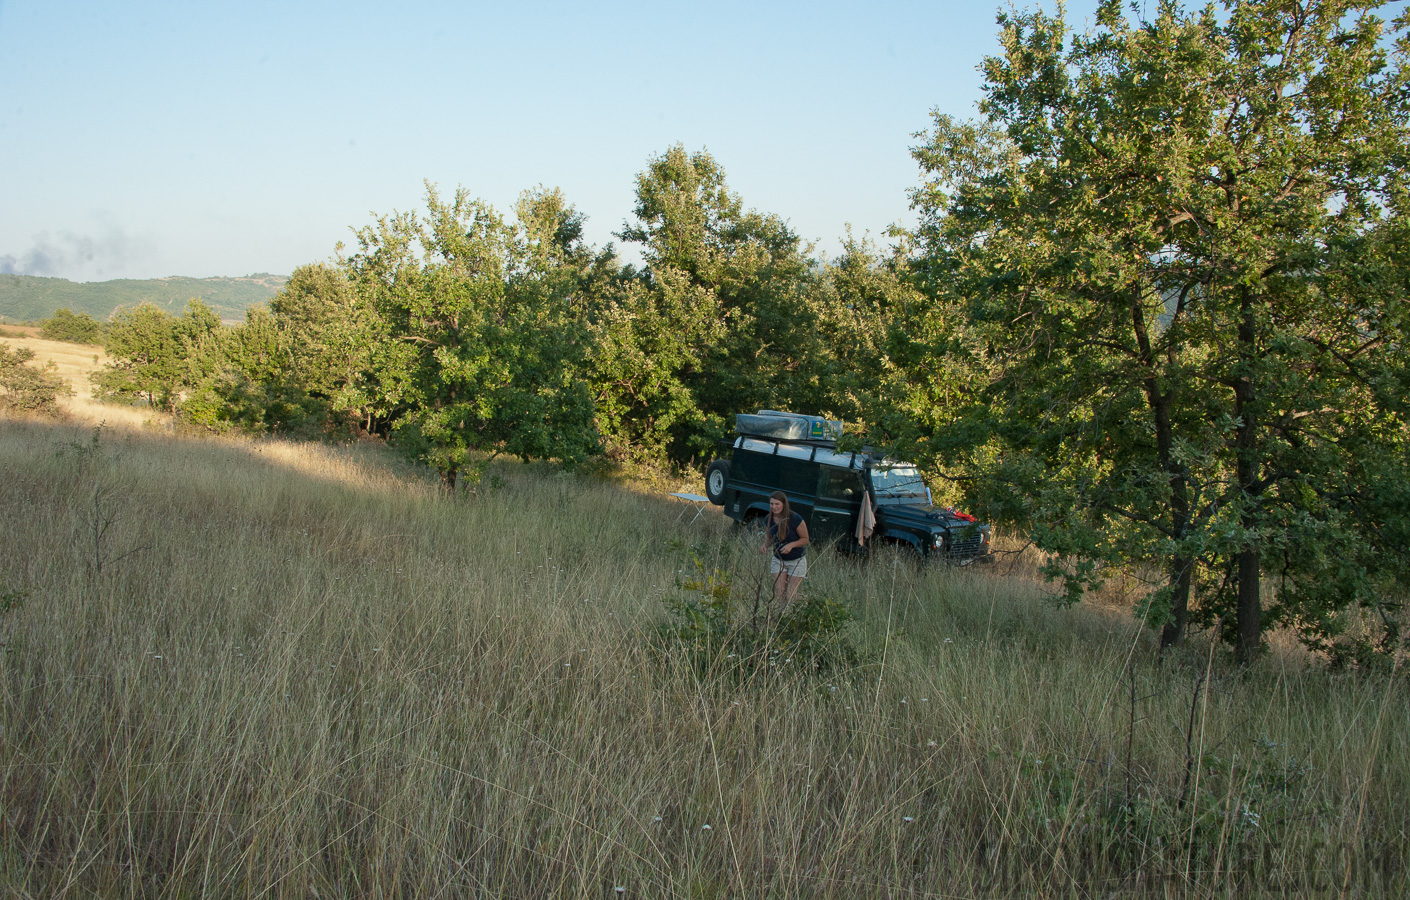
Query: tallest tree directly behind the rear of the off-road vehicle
xmin=595 ymin=145 xmax=821 ymax=458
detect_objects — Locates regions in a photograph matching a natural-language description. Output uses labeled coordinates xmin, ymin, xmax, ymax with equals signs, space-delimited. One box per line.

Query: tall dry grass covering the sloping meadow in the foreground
xmin=0 ymin=411 xmax=1410 ymax=897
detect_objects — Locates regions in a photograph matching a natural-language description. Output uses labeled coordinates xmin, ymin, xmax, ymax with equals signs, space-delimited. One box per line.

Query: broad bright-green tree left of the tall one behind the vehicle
xmin=347 ymin=185 xmax=596 ymax=488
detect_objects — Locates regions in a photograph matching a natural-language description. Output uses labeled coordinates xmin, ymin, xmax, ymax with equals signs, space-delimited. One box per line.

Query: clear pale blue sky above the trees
xmin=0 ymin=0 xmax=1096 ymax=281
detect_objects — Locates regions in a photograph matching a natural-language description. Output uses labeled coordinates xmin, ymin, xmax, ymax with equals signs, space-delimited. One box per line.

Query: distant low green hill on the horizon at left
xmin=0 ymin=272 xmax=288 ymax=322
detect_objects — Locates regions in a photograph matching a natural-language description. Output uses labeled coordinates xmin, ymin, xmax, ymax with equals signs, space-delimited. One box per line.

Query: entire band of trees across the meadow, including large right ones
xmin=88 ymin=0 xmax=1410 ymax=664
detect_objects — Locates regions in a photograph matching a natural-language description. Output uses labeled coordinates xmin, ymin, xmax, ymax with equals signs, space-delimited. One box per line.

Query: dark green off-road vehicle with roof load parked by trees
xmin=705 ymin=409 xmax=990 ymax=563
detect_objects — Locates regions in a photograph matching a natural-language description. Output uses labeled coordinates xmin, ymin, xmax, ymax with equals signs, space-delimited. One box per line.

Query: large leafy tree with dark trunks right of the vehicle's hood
xmin=911 ymin=0 xmax=1407 ymax=660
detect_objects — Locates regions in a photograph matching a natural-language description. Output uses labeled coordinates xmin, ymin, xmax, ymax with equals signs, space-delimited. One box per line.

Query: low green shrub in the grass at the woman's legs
xmin=661 ymin=553 xmax=862 ymax=677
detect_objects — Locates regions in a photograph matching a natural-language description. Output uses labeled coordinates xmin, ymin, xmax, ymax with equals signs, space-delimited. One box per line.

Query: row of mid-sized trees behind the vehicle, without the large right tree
xmin=96 ymin=147 xmax=921 ymax=485
